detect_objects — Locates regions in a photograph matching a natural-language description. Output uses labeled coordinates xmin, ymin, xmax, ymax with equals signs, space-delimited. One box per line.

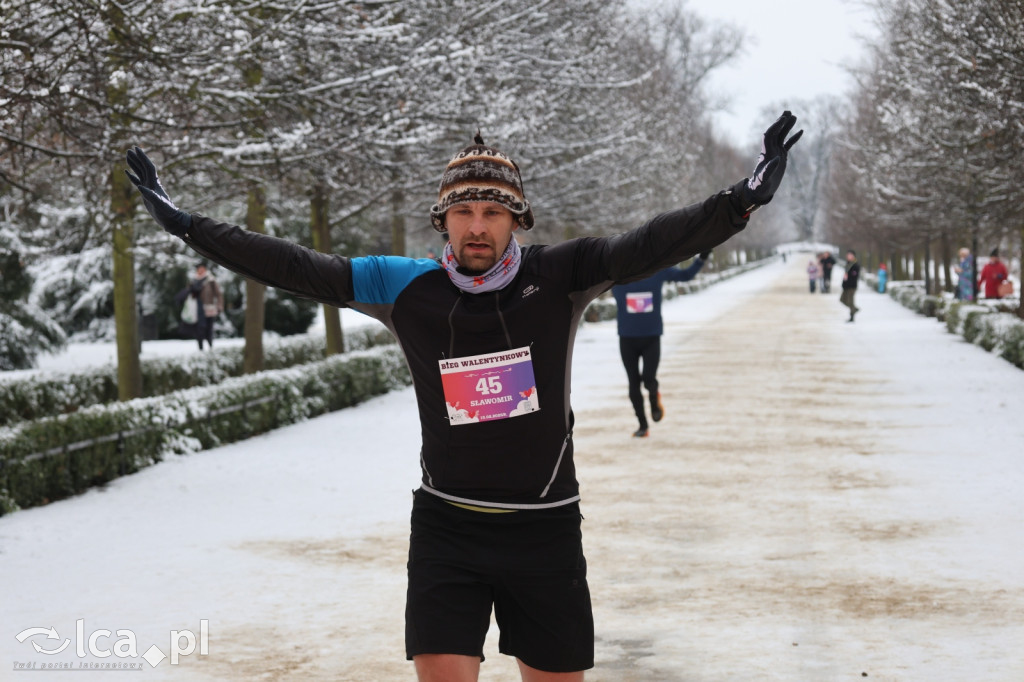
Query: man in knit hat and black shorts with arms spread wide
xmin=126 ymin=112 xmax=803 ymax=682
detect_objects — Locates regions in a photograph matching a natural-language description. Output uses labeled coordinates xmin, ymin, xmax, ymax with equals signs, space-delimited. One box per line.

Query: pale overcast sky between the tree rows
xmin=651 ymin=0 xmax=874 ymax=146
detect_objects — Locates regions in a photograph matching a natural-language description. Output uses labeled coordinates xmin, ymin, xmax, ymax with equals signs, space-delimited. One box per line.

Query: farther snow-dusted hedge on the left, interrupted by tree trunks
xmin=0 ymin=325 xmax=394 ymax=426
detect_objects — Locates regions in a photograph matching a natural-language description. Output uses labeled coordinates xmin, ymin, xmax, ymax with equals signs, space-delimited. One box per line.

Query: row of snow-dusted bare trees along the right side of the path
xmin=829 ymin=0 xmax=1024 ymax=303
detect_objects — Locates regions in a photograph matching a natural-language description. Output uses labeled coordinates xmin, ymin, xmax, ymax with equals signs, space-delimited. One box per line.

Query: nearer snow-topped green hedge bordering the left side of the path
xmin=0 ymin=345 xmax=411 ymax=514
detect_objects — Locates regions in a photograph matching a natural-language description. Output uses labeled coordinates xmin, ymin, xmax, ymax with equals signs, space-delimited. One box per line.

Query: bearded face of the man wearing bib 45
xmin=444 ymin=202 xmax=519 ymax=273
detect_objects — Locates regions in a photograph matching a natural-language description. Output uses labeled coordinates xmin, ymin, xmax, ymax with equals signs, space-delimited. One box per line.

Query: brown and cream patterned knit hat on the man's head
xmin=430 ymin=132 xmax=534 ymax=232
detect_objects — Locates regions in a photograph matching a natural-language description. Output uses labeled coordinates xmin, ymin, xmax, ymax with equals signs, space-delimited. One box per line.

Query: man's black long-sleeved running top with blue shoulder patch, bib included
xmin=184 ymin=185 xmax=748 ymax=509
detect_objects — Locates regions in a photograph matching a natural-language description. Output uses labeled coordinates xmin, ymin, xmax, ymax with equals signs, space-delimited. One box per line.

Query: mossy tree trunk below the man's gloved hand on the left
xmin=111 ymin=162 xmax=142 ymax=400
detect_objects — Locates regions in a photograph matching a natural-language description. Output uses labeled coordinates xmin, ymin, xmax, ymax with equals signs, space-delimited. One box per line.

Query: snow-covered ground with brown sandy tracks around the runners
xmin=0 ymin=258 xmax=1024 ymax=682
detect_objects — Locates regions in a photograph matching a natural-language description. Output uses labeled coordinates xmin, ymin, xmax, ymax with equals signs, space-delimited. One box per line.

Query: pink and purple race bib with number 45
xmin=437 ymin=346 xmax=541 ymax=426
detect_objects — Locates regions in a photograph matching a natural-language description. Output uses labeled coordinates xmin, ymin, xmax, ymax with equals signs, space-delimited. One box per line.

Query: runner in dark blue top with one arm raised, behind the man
xmin=611 ymin=252 xmax=711 ymax=438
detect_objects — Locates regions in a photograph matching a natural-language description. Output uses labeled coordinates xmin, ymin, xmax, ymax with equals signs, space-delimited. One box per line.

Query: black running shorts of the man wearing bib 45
xmin=406 ymin=491 xmax=594 ymax=673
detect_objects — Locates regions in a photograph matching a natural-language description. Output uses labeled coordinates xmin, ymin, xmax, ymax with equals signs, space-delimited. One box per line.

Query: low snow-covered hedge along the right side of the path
xmin=889 ymin=284 xmax=1024 ymax=369
